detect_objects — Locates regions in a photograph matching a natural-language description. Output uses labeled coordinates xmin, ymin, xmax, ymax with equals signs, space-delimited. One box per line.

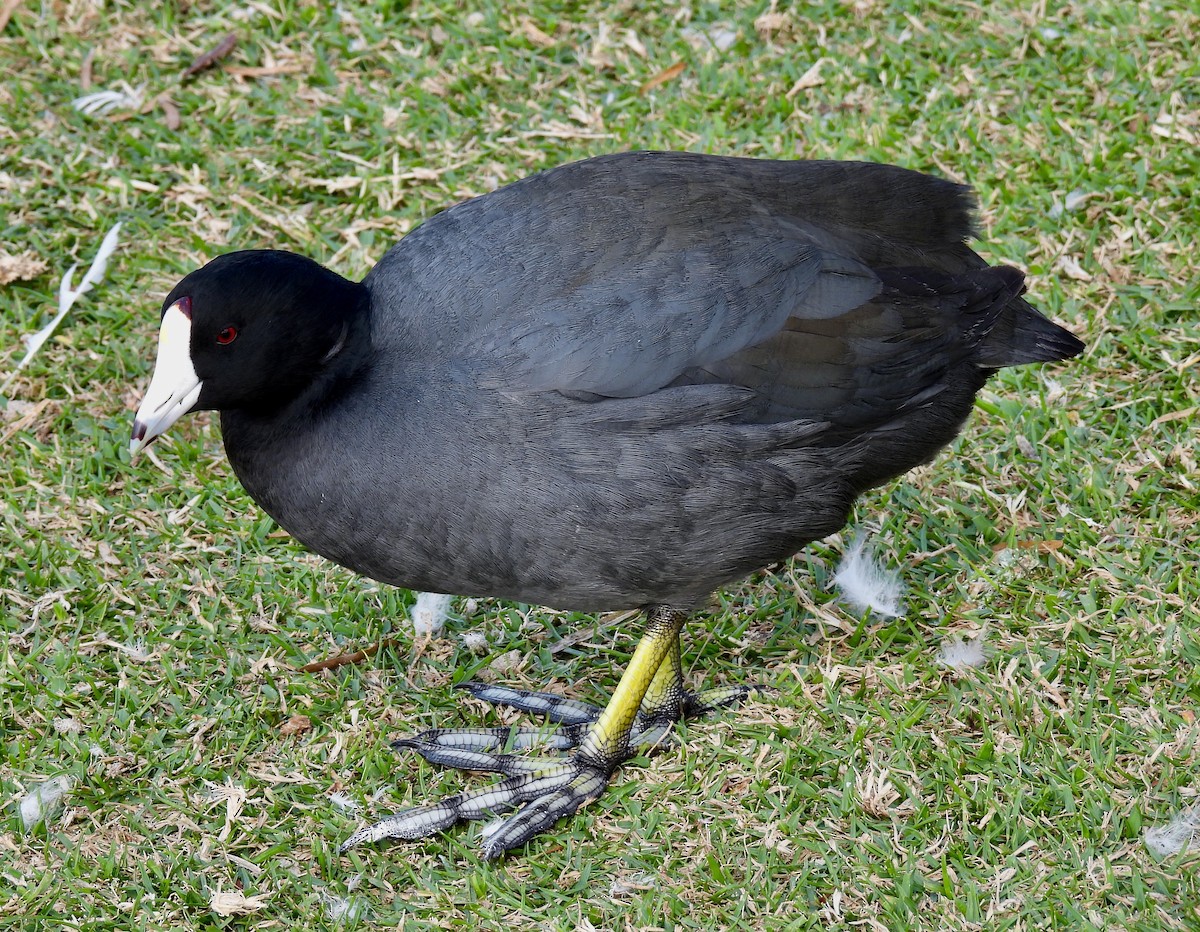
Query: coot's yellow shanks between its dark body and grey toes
xmin=578 ymin=606 xmax=688 ymax=766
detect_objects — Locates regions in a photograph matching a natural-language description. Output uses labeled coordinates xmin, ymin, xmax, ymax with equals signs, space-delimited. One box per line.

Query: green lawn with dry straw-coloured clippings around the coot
xmin=0 ymin=0 xmax=1200 ymax=930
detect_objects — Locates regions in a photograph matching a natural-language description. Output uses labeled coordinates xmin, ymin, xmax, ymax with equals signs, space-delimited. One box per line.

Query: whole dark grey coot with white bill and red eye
xmin=132 ymin=152 xmax=1082 ymax=856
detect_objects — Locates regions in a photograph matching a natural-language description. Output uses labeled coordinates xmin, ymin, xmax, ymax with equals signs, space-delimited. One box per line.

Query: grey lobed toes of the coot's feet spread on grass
xmin=341 ymin=683 xmax=762 ymax=859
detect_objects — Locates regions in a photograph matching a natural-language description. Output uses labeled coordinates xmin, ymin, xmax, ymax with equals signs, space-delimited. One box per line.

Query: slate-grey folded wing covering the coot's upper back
xmin=366 ymin=154 xmax=978 ymax=397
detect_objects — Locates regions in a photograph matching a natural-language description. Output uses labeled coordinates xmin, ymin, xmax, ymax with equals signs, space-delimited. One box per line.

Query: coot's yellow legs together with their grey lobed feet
xmin=342 ymin=606 xmax=754 ymax=858
